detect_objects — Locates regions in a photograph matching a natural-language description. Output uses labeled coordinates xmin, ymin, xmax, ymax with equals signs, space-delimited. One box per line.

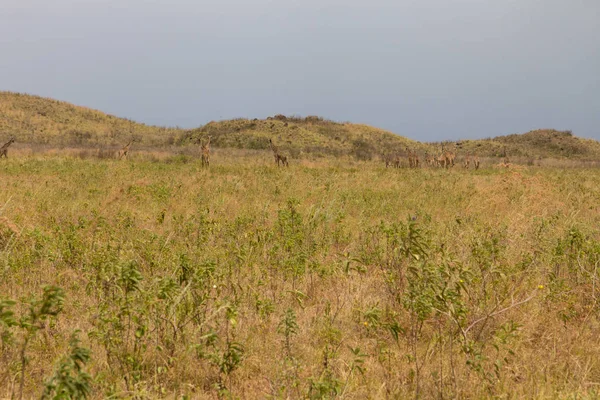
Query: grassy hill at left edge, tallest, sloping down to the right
xmin=0 ymin=92 xmax=180 ymax=145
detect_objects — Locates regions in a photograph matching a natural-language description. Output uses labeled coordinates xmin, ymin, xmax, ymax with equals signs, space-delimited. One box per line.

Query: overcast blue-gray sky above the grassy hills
xmin=0 ymin=0 xmax=600 ymax=140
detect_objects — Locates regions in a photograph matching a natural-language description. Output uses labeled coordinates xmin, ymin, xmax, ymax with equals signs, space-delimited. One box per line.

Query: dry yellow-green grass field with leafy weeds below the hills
xmin=0 ymin=148 xmax=600 ymax=399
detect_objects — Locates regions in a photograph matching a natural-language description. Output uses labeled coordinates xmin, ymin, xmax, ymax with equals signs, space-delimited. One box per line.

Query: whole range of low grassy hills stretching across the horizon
xmin=0 ymin=92 xmax=600 ymax=160
